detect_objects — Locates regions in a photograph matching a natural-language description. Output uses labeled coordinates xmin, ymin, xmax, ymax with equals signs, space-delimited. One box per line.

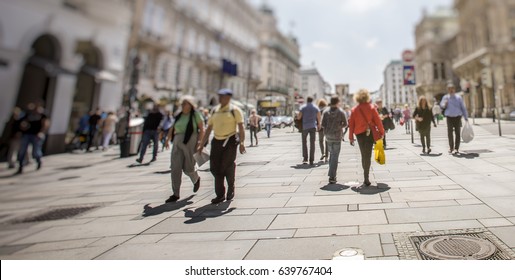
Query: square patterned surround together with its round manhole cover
xmin=394 ymin=229 xmax=515 ymax=260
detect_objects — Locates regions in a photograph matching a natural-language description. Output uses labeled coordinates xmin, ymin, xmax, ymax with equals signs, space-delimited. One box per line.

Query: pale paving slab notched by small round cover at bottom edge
xmin=245 ymin=235 xmax=382 ymax=260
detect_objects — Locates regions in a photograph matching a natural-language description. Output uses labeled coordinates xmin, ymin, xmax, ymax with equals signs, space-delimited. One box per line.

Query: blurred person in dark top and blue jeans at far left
xmin=16 ymin=103 xmax=50 ymax=174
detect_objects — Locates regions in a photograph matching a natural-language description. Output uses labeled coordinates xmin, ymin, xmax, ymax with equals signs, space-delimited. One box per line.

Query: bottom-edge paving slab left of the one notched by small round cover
xmin=95 ymin=240 xmax=256 ymax=260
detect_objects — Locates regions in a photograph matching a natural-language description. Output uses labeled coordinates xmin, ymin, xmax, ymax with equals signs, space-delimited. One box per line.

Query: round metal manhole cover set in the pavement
xmin=420 ymin=235 xmax=496 ymax=260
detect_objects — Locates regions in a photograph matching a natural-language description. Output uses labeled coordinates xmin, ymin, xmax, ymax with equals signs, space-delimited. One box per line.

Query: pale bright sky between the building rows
xmin=250 ymin=0 xmax=453 ymax=92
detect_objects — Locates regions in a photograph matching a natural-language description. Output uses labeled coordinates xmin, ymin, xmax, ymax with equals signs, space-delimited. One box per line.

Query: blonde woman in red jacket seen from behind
xmin=349 ymin=89 xmax=384 ymax=187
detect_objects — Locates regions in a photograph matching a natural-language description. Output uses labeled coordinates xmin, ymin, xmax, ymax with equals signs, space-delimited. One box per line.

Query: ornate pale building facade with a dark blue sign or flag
xmin=127 ymin=0 xmax=261 ymax=111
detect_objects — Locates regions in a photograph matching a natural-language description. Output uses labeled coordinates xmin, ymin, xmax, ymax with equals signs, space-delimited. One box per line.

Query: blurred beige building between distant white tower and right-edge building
xmin=415 ymin=7 xmax=458 ymax=105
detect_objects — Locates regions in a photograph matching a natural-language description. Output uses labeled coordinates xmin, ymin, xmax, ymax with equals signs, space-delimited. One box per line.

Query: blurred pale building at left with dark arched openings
xmin=0 ymin=0 xmax=131 ymax=154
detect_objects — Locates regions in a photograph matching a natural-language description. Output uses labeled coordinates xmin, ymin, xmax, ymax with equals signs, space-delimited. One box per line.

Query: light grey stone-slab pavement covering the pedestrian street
xmin=0 ymin=120 xmax=515 ymax=260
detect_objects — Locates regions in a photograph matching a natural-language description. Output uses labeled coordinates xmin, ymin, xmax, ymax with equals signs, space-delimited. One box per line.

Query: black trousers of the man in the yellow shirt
xmin=209 ymin=136 xmax=239 ymax=197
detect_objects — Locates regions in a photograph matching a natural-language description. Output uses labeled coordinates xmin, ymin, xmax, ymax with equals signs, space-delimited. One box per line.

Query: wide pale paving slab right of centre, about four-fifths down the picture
xmin=270 ymin=211 xmax=387 ymax=229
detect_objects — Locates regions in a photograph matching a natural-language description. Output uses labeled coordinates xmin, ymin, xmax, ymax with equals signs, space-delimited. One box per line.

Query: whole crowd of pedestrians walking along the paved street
xmin=4 ymin=84 xmax=468 ymax=204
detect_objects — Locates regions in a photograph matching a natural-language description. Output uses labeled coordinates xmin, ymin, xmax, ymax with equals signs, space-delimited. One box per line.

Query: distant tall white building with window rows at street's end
xmin=380 ymin=60 xmax=417 ymax=108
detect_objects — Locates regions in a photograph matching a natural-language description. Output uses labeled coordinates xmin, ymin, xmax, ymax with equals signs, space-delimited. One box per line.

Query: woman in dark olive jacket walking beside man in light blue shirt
xmin=413 ymin=96 xmax=438 ymax=155
